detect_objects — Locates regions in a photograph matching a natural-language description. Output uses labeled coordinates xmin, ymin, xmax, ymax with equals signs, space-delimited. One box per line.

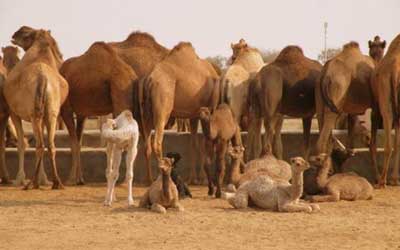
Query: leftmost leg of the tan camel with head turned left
xmin=11 ymin=114 xmax=26 ymax=186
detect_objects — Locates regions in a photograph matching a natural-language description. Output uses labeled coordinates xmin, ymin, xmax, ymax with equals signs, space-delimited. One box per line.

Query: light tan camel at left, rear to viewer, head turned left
xmin=3 ymin=26 xmax=68 ymax=189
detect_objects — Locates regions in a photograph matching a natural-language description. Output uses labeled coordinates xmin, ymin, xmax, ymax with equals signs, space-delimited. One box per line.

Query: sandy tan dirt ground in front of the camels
xmin=0 ymin=184 xmax=400 ymax=250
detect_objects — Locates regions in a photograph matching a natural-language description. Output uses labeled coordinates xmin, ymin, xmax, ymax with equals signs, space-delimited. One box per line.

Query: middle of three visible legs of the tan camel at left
xmin=24 ymin=118 xmax=44 ymax=190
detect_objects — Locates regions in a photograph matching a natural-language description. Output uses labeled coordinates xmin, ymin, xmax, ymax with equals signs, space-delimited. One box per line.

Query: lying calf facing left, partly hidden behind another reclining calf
xmin=228 ymin=146 xmax=292 ymax=192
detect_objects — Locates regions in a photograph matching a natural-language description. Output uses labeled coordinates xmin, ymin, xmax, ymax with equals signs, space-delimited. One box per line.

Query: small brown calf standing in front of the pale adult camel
xmin=199 ymin=104 xmax=242 ymax=198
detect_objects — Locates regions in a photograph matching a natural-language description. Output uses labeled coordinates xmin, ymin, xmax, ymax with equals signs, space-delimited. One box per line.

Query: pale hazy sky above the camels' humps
xmin=0 ymin=0 xmax=400 ymax=59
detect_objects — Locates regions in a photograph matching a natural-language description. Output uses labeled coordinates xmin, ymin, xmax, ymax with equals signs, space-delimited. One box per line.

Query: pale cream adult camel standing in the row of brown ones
xmin=221 ymin=39 xmax=264 ymax=160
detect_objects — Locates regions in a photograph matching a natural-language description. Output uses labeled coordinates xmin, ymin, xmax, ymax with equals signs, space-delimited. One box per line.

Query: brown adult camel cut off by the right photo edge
xmin=371 ymin=35 xmax=400 ymax=188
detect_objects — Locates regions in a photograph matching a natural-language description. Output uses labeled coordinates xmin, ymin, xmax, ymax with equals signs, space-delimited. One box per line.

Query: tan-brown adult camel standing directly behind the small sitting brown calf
xmin=138 ymin=42 xmax=220 ymax=186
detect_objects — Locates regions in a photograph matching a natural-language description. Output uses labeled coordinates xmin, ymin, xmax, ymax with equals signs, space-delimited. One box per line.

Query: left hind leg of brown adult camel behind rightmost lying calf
xmin=317 ymin=110 xmax=338 ymax=153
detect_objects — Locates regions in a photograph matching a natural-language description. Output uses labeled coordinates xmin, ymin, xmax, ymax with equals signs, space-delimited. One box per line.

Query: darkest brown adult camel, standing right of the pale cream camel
xmin=248 ymin=46 xmax=322 ymax=159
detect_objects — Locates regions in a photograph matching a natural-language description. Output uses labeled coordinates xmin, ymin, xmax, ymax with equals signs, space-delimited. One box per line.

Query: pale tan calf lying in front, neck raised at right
xmin=224 ymin=157 xmax=320 ymax=213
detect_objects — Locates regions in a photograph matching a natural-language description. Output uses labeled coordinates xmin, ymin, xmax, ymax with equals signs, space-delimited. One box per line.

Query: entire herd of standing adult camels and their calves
xmin=0 ymin=26 xmax=400 ymax=212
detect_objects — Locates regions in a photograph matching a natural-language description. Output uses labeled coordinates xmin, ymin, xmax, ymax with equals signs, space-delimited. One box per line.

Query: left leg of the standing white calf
xmin=104 ymin=145 xmax=120 ymax=206
